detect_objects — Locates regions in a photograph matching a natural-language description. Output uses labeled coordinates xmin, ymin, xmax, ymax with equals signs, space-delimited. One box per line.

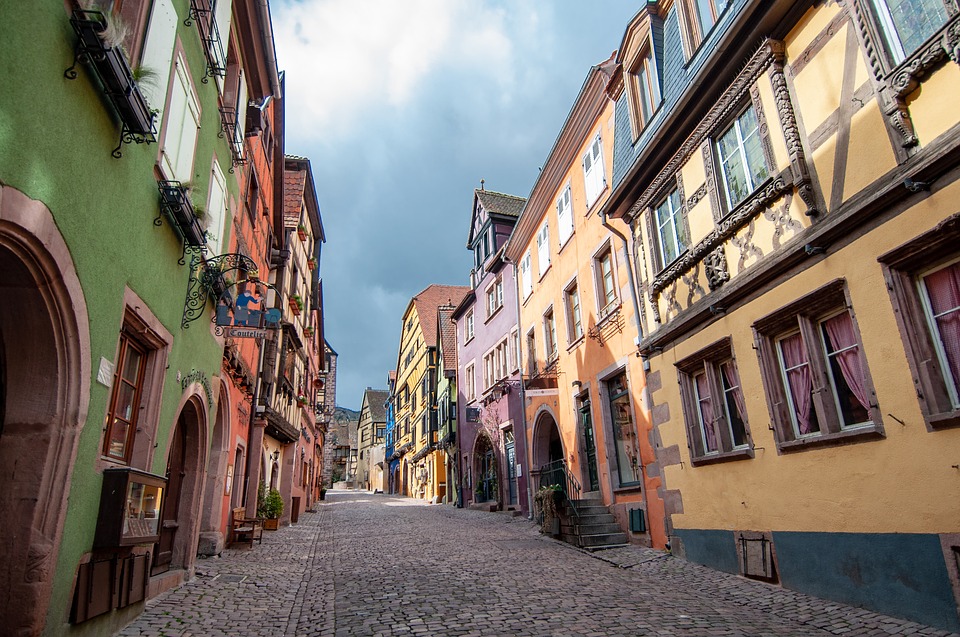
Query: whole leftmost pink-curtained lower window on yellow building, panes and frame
xmin=677 ymin=339 xmax=753 ymax=462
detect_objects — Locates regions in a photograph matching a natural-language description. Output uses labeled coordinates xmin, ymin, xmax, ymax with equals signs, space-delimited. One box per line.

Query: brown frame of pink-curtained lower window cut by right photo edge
xmin=877 ymin=213 xmax=960 ymax=432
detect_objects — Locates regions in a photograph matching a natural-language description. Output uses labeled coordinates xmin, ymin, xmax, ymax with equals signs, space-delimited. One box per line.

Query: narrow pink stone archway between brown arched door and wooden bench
xmin=197 ymin=383 xmax=230 ymax=555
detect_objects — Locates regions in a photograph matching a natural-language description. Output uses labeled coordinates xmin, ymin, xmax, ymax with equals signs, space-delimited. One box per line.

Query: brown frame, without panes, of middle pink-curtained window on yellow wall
xmin=752 ymin=279 xmax=884 ymax=451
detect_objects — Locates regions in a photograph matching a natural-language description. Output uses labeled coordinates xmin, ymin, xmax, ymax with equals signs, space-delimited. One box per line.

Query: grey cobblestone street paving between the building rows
xmin=119 ymin=491 xmax=960 ymax=637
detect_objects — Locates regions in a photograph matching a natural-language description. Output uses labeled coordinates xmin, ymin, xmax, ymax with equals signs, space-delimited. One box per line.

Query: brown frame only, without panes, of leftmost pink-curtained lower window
xmin=676 ymin=337 xmax=754 ymax=466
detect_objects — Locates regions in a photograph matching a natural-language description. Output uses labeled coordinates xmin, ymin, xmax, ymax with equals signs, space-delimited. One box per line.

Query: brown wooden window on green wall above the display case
xmin=103 ymin=331 xmax=147 ymax=463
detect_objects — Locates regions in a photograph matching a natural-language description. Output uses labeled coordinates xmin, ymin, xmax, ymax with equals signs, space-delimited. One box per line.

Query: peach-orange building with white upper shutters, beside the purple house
xmin=506 ymin=58 xmax=666 ymax=547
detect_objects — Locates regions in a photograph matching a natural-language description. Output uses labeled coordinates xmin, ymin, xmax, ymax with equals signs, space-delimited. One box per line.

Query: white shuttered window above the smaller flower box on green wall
xmin=161 ymin=58 xmax=200 ymax=182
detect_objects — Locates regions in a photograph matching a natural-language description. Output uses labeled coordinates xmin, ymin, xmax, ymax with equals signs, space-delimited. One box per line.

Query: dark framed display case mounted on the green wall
xmin=93 ymin=467 xmax=167 ymax=549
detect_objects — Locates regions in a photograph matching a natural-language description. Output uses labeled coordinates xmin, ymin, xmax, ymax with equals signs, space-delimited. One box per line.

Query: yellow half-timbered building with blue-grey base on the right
xmin=605 ymin=0 xmax=960 ymax=631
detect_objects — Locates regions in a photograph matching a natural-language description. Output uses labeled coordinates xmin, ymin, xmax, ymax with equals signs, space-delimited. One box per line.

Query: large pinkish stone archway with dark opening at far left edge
xmin=0 ymin=187 xmax=91 ymax=635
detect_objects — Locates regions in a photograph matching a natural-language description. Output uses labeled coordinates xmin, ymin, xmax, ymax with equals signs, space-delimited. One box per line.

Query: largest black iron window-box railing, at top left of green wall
xmin=63 ymin=9 xmax=157 ymax=158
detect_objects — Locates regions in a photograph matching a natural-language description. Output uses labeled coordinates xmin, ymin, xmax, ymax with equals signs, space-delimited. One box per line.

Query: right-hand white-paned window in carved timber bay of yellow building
xmin=717 ymin=105 xmax=769 ymax=210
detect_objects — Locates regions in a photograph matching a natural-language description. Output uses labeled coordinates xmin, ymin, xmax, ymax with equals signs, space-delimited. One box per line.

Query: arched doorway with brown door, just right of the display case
xmin=151 ymin=398 xmax=207 ymax=575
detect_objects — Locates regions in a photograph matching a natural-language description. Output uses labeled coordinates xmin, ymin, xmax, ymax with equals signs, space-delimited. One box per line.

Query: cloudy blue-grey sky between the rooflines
xmin=271 ymin=0 xmax=641 ymax=409
